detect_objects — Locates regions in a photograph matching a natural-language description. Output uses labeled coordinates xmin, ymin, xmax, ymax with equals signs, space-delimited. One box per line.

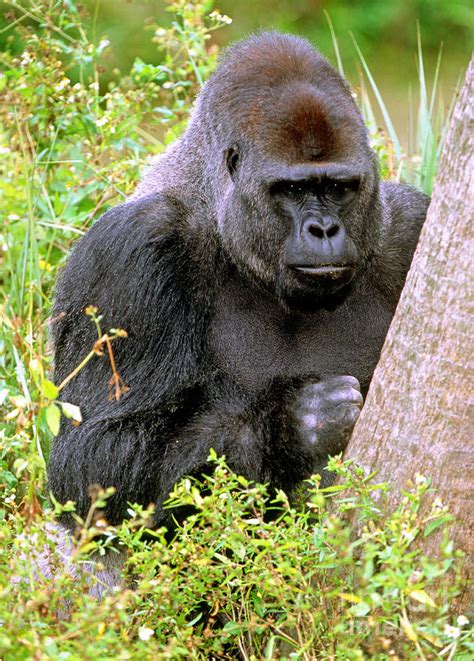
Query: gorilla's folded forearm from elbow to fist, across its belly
xmin=49 ymin=366 xmax=362 ymax=526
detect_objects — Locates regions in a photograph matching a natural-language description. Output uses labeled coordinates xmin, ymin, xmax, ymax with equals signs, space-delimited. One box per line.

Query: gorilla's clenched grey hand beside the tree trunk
xmin=293 ymin=376 xmax=363 ymax=468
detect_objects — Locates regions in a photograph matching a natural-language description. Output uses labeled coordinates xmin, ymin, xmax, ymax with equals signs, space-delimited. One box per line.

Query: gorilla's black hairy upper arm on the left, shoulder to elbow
xmin=51 ymin=196 xmax=215 ymax=419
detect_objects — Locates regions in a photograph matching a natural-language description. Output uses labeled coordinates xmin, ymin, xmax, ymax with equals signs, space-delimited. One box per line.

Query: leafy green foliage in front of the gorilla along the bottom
xmin=0 ymin=456 xmax=473 ymax=660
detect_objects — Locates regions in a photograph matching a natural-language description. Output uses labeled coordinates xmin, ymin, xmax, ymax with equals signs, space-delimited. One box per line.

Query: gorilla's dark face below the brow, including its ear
xmin=220 ymin=146 xmax=366 ymax=309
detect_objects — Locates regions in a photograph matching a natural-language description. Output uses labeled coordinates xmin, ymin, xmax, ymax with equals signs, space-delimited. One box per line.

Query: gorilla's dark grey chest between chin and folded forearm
xmin=210 ymin=290 xmax=391 ymax=392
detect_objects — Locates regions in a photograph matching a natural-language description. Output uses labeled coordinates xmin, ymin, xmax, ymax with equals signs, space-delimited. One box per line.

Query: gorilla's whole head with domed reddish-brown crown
xmin=191 ymin=33 xmax=379 ymax=308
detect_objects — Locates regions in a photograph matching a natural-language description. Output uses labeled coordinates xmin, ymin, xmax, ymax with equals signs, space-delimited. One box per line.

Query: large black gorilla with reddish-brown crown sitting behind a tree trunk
xmin=48 ymin=33 xmax=428 ymax=527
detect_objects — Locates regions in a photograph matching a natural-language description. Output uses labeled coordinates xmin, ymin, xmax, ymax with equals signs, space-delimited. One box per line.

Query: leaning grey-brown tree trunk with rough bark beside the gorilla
xmin=346 ymin=61 xmax=474 ymax=606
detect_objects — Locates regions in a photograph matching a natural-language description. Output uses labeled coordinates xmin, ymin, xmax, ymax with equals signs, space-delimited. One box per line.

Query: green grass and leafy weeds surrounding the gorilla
xmin=0 ymin=0 xmax=472 ymax=659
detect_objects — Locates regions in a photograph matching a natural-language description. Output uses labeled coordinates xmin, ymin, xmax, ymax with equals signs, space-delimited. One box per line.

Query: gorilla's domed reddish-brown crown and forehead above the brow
xmin=200 ymin=33 xmax=366 ymax=162
